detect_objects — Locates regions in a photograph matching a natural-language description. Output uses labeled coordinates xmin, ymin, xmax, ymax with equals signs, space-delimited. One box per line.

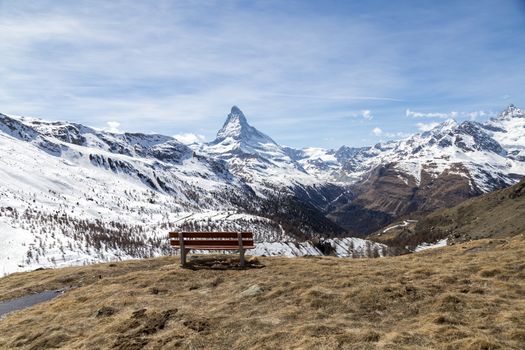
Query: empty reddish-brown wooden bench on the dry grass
xmin=169 ymin=232 xmax=255 ymax=266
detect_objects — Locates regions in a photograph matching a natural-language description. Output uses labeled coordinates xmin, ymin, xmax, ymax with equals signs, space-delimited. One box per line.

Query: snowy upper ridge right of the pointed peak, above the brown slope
xmin=287 ymin=105 xmax=525 ymax=192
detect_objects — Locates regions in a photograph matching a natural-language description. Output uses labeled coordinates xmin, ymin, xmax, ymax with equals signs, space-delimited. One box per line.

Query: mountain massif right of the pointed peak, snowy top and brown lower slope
xmin=280 ymin=105 xmax=525 ymax=235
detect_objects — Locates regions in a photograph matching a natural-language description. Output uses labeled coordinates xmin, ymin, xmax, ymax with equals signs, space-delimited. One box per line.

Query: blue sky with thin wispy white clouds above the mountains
xmin=0 ymin=0 xmax=525 ymax=147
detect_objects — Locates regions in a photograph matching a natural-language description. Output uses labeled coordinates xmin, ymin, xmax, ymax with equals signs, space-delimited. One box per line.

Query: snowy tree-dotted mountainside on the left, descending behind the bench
xmin=0 ymin=110 xmax=374 ymax=273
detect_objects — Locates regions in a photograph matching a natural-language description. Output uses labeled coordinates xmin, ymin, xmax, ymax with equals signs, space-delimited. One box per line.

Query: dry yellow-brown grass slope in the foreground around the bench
xmin=0 ymin=235 xmax=525 ymax=349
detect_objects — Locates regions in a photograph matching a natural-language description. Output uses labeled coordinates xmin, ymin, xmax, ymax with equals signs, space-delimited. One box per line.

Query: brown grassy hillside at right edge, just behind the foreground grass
xmin=369 ymin=178 xmax=525 ymax=247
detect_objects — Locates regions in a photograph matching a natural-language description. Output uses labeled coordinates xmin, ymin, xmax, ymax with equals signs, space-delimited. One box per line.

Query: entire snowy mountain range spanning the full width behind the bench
xmin=0 ymin=105 xmax=525 ymax=273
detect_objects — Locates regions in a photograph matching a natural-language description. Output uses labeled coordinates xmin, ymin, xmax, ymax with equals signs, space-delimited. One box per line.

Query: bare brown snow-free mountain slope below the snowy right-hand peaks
xmin=328 ymin=163 xmax=482 ymax=237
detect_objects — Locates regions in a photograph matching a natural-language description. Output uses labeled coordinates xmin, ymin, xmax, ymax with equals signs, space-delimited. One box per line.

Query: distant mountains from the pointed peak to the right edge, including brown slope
xmin=203 ymin=105 xmax=525 ymax=236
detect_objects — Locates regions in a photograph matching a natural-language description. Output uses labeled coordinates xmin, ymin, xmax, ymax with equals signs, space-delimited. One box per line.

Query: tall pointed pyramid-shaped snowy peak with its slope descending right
xmin=192 ymin=106 xmax=350 ymax=231
